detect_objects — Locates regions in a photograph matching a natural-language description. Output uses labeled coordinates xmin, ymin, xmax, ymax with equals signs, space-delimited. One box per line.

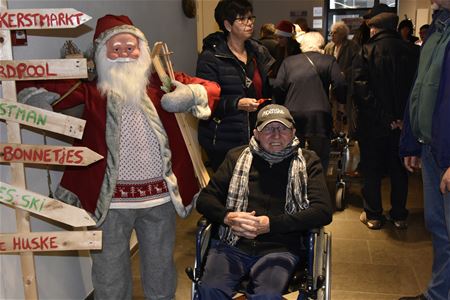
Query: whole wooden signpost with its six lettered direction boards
xmin=0 ymin=0 xmax=102 ymax=299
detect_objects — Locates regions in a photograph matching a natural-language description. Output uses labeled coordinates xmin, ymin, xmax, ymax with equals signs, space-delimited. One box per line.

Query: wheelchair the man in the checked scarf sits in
xmin=185 ymin=218 xmax=331 ymax=300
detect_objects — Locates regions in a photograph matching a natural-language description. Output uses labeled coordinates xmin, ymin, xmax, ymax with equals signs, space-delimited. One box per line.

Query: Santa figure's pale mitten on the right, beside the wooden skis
xmin=161 ymin=80 xmax=211 ymax=119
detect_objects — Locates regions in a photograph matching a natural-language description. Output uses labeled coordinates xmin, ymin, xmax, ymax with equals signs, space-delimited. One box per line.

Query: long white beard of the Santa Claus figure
xmin=95 ymin=43 xmax=151 ymax=104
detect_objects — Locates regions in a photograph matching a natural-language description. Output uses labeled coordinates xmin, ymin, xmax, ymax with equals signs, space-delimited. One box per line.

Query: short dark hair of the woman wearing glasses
xmin=214 ymin=0 xmax=253 ymax=34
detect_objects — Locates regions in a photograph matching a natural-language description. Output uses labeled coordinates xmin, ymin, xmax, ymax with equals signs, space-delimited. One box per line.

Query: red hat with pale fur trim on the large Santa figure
xmin=94 ymin=15 xmax=147 ymax=48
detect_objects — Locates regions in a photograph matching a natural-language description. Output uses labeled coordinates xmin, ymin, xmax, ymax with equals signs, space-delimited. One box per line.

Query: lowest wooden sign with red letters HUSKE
xmin=0 ymin=231 xmax=102 ymax=254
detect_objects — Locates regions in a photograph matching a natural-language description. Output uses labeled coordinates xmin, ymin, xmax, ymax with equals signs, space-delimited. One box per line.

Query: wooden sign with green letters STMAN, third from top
xmin=0 ymin=98 xmax=86 ymax=139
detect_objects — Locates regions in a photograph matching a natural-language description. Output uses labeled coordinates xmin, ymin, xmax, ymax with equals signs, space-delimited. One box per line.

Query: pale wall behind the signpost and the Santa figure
xmin=0 ymin=0 xmax=197 ymax=299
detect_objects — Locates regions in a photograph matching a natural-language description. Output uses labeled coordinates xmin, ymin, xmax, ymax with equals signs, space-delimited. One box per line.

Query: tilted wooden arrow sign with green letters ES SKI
xmin=0 ymin=181 xmax=95 ymax=227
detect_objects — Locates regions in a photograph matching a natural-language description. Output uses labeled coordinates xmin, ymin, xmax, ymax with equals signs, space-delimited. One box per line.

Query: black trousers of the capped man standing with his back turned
xmin=360 ymin=130 xmax=408 ymax=220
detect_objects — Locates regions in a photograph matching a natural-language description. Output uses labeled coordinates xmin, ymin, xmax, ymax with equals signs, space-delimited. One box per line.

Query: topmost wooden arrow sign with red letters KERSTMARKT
xmin=0 ymin=8 xmax=92 ymax=30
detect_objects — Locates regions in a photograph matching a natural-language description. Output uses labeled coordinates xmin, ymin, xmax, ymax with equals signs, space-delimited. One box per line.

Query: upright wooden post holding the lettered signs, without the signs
xmin=0 ymin=0 xmax=39 ymax=299
